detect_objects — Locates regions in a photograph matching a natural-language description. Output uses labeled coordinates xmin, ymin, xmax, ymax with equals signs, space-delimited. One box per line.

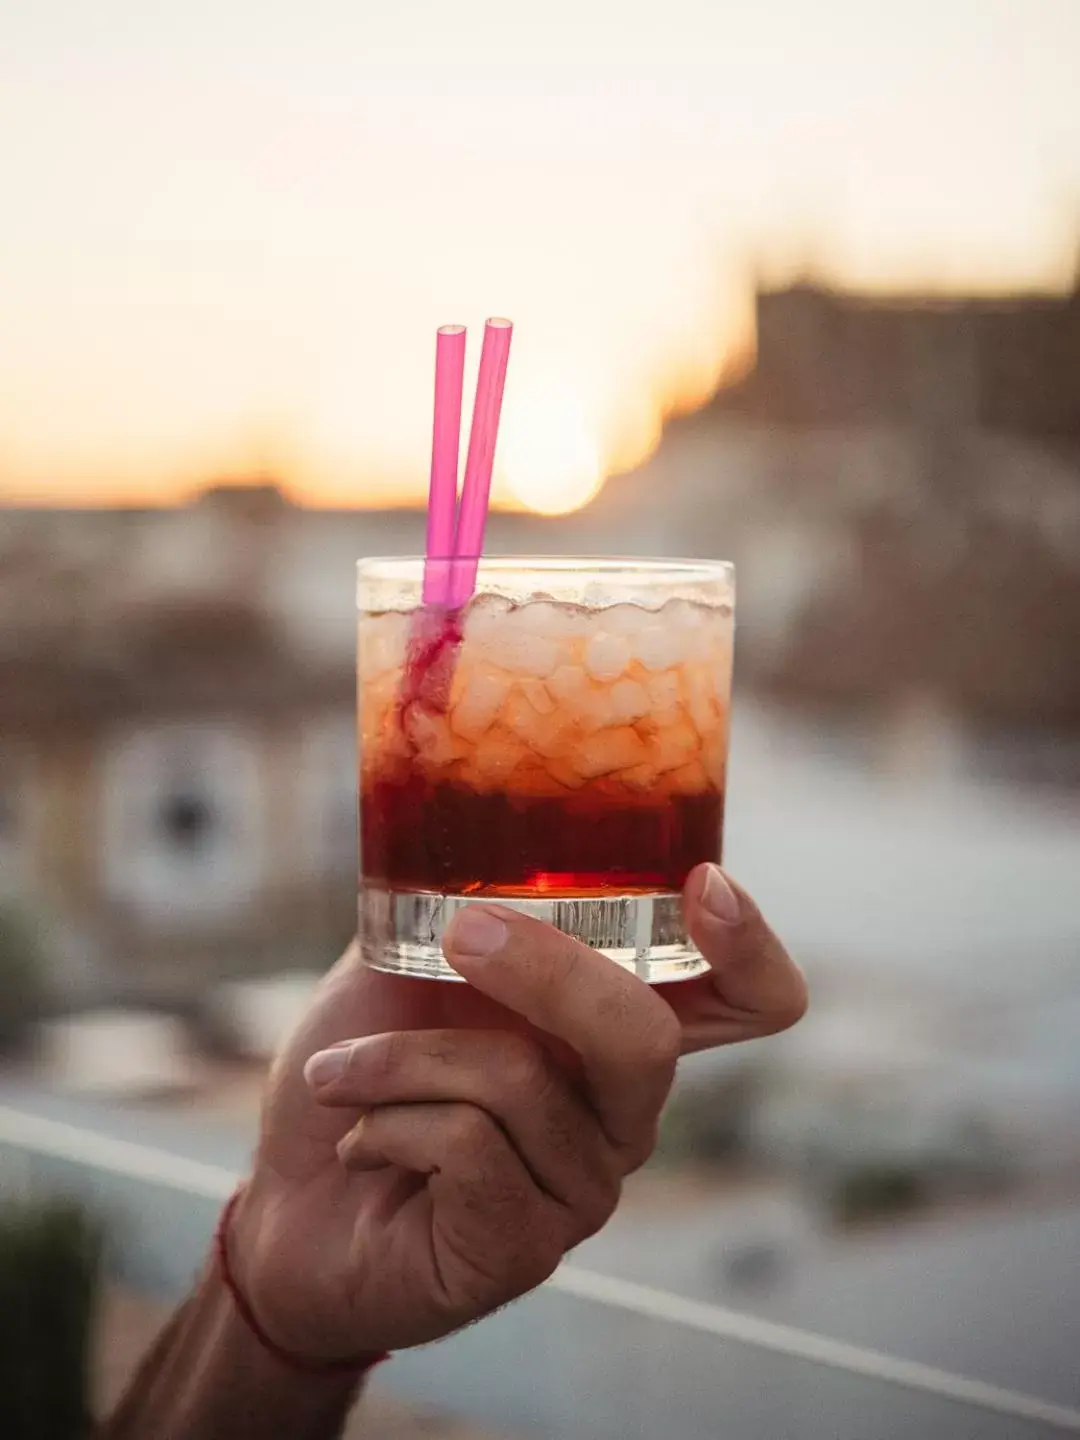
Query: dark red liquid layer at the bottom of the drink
xmin=360 ymin=773 xmax=724 ymax=896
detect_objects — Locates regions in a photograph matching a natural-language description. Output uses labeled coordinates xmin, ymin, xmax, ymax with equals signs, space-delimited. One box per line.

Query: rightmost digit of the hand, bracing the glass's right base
xmin=680 ymin=865 xmax=806 ymax=1050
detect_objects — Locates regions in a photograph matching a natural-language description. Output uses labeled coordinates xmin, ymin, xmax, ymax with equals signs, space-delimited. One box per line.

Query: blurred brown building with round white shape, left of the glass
xmin=0 ymin=490 xmax=365 ymax=1001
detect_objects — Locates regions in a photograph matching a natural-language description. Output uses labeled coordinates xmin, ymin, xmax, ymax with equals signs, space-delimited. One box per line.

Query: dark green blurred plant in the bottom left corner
xmin=0 ymin=1200 xmax=102 ymax=1440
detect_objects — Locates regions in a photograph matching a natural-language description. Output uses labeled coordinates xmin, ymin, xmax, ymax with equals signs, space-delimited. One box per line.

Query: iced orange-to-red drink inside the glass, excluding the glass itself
xmin=360 ymin=598 xmax=730 ymax=897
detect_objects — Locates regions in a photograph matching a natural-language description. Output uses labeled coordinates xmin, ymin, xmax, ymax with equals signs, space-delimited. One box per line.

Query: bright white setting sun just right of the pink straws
xmin=498 ymin=365 xmax=605 ymax=516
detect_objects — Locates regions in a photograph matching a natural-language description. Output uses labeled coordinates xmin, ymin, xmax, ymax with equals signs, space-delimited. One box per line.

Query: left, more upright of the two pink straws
xmin=423 ymin=325 xmax=465 ymax=605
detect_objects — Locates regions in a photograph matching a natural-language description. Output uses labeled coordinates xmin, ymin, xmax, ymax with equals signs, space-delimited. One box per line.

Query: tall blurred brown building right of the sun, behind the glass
xmin=592 ymin=267 xmax=1080 ymax=743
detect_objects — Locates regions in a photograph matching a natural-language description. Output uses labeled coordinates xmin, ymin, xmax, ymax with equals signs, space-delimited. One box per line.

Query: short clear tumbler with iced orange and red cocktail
xmin=359 ymin=557 xmax=734 ymax=982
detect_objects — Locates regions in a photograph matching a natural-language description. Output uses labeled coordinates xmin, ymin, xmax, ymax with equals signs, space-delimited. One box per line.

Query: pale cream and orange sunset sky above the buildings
xmin=0 ymin=0 xmax=1080 ymax=508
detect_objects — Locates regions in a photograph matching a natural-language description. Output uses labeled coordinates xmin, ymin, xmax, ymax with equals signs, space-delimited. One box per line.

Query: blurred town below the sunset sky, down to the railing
xmin=0 ymin=271 xmax=1080 ymax=1428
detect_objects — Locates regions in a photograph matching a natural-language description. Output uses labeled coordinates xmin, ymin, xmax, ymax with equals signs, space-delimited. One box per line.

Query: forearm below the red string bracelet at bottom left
xmin=101 ymin=1264 xmax=363 ymax=1440
